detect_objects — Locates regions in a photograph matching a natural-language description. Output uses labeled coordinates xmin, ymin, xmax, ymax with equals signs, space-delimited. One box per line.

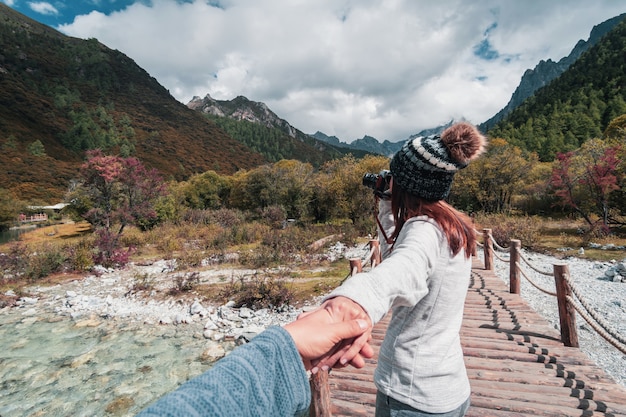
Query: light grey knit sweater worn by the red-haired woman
xmin=326 ymin=201 xmax=471 ymax=413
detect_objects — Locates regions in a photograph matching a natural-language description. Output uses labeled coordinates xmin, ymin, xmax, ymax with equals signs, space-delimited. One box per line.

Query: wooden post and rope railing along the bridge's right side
xmin=482 ymin=229 xmax=626 ymax=353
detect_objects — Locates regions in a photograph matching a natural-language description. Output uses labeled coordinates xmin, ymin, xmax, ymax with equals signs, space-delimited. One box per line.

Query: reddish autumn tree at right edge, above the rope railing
xmin=550 ymin=139 xmax=623 ymax=232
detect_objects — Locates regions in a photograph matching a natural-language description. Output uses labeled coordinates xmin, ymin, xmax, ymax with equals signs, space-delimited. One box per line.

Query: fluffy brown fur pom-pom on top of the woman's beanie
xmin=441 ymin=122 xmax=487 ymax=163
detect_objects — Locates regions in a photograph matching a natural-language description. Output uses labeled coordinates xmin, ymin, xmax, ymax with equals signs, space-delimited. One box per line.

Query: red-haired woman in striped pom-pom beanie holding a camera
xmin=314 ymin=123 xmax=486 ymax=417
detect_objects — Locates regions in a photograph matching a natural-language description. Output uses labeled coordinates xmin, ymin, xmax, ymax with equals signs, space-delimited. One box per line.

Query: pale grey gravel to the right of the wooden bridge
xmin=478 ymin=250 xmax=626 ymax=386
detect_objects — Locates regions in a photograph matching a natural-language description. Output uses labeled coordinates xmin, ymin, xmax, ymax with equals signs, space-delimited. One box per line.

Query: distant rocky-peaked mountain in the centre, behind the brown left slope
xmin=187 ymin=94 xmax=366 ymax=162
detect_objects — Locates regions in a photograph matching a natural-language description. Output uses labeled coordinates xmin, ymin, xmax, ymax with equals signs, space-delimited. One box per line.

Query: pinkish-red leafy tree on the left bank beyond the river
xmin=70 ymin=150 xmax=164 ymax=265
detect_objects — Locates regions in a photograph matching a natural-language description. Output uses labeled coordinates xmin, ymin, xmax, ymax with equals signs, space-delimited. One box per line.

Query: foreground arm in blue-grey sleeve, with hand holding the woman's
xmin=139 ymin=311 xmax=373 ymax=417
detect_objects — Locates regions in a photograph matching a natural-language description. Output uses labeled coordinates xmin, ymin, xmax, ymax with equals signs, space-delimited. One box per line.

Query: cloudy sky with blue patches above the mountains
xmin=0 ymin=0 xmax=626 ymax=143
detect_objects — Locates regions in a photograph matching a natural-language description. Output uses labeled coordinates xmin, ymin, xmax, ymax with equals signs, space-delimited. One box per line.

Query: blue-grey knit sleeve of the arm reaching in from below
xmin=138 ymin=326 xmax=311 ymax=417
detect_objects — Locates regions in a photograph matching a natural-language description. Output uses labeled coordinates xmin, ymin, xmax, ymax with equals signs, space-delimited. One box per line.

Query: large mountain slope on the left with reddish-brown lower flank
xmin=0 ymin=3 xmax=267 ymax=202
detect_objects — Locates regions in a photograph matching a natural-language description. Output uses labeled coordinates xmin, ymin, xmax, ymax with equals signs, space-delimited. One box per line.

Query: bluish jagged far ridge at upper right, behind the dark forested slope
xmin=479 ymin=13 xmax=626 ymax=131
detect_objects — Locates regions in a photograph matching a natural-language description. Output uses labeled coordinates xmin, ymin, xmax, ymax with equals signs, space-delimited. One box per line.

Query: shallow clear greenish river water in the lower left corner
xmin=0 ymin=309 xmax=232 ymax=417
